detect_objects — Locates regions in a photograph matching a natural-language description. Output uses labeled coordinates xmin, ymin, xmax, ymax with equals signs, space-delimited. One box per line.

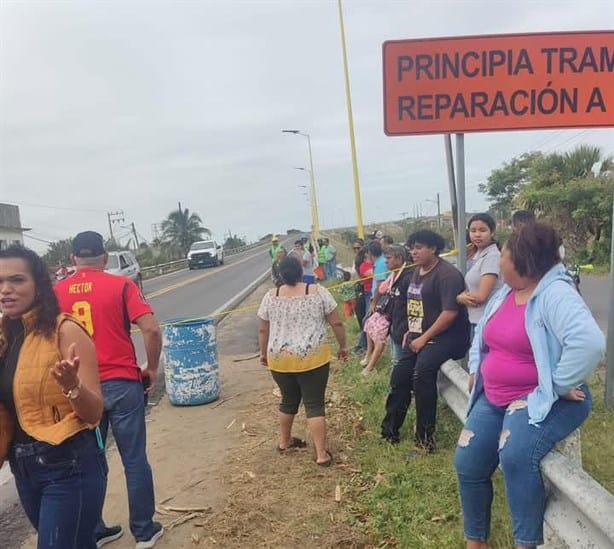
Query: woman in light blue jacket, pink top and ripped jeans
xmin=455 ymin=224 xmax=605 ymax=549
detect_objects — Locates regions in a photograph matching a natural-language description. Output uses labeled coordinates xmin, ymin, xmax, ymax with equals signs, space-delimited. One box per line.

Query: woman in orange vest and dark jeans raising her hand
xmin=0 ymin=246 xmax=107 ymax=549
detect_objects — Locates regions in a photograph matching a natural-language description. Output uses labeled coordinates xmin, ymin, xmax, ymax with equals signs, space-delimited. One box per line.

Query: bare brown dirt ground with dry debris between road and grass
xmin=22 ymin=287 xmax=370 ymax=549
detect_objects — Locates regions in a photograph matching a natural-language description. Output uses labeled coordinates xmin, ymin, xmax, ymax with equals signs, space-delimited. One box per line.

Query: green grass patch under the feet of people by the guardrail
xmin=331 ymin=320 xmax=513 ymax=549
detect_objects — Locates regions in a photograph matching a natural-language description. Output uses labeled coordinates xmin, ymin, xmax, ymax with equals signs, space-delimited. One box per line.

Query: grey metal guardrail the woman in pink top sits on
xmin=438 ymin=360 xmax=614 ymax=549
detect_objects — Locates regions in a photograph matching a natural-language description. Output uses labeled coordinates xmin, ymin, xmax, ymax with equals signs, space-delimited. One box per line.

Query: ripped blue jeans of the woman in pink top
xmin=454 ymin=385 xmax=591 ymax=546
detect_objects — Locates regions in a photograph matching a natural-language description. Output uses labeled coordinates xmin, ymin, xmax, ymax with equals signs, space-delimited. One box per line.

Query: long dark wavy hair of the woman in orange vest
xmin=0 ymin=245 xmax=60 ymax=337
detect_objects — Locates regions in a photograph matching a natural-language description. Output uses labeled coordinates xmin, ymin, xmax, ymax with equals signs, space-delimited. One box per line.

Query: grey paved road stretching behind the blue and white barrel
xmin=0 ymin=242 xmax=271 ymax=549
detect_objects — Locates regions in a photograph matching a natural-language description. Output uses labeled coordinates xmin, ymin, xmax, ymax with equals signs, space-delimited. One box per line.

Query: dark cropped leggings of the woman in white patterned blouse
xmin=271 ymin=363 xmax=330 ymax=417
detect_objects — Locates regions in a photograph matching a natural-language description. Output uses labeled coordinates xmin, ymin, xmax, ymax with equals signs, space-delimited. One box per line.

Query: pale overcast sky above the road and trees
xmin=0 ymin=0 xmax=614 ymax=250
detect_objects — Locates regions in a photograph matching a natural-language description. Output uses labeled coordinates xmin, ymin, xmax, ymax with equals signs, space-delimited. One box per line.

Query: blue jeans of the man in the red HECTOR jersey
xmin=97 ymin=379 xmax=156 ymax=541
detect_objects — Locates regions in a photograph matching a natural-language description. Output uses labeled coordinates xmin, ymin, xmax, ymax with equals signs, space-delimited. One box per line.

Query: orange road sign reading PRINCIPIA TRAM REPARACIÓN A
xmin=383 ymin=31 xmax=614 ymax=136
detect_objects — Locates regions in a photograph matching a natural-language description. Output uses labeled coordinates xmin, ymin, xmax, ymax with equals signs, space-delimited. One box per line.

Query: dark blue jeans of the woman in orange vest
xmin=9 ymin=430 xmax=108 ymax=549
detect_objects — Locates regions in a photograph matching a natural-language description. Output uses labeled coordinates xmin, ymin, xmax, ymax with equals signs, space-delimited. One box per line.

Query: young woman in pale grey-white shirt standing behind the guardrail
xmin=456 ymin=213 xmax=503 ymax=334
